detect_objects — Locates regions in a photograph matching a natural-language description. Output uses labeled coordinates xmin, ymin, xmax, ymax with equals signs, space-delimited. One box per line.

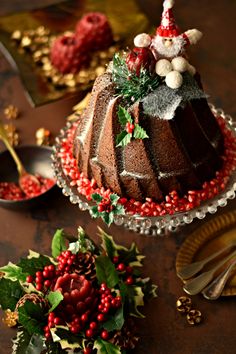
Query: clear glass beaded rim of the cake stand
xmin=52 ymin=104 xmax=236 ymax=236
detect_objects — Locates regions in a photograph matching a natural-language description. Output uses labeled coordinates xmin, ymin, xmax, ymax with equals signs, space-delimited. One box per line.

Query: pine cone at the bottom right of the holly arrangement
xmin=110 ymin=319 xmax=139 ymax=350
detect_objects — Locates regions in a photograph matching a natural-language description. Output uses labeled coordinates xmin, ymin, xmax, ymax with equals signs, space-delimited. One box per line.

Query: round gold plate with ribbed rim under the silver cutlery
xmin=176 ymin=211 xmax=236 ymax=296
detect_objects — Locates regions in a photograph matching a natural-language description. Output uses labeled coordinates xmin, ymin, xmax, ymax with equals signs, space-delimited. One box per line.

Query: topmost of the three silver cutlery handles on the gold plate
xmin=177 ymin=241 xmax=236 ymax=279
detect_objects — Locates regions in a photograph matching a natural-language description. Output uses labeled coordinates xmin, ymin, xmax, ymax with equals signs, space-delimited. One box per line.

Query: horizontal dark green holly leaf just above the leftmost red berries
xmin=17 ymin=252 xmax=53 ymax=275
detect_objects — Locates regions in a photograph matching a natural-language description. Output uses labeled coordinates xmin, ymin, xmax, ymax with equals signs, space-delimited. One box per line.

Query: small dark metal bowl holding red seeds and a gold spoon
xmin=0 ymin=145 xmax=56 ymax=210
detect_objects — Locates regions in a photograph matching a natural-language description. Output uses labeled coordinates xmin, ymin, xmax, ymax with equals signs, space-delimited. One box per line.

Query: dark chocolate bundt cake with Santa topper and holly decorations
xmin=73 ymin=0 xmax=224 ymax=201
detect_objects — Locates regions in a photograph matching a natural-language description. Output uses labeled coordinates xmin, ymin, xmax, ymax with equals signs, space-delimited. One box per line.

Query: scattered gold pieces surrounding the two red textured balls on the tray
xmin=11 ymin=26 xmax=120 ymax=90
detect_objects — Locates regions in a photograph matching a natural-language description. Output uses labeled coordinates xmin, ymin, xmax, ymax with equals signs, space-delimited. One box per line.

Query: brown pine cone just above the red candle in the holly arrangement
xmin=74 ymin=252 xmax=96 ymax=281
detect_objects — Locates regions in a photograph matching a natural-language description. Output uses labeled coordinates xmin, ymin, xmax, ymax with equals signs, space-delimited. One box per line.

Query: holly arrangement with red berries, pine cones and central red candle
xmin=0 ymin=228 xmax=157 ymax=354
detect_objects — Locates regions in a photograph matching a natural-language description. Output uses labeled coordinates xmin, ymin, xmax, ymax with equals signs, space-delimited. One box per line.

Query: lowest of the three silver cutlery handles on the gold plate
xmin=202 ymin=259 xmax=236 ymax=300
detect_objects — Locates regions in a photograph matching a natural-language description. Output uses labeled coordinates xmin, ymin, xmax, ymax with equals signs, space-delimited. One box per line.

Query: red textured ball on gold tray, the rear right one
xmin=75 ymin=12 xmax=113 ymax=50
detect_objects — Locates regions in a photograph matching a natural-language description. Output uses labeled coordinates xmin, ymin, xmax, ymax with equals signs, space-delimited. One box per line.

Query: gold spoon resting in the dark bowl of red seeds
xmin=0 ymin=121 xmax=40 ymax=196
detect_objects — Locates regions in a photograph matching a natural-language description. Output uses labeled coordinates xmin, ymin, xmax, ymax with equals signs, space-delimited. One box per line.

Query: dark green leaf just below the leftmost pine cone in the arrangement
xmin=18 ymin=301 xmax=47 ymax=335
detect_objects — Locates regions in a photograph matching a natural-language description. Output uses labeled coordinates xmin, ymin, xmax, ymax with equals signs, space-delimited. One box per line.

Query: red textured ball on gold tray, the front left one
xmin=50 ymin=34 xmax=89 ymax=74
